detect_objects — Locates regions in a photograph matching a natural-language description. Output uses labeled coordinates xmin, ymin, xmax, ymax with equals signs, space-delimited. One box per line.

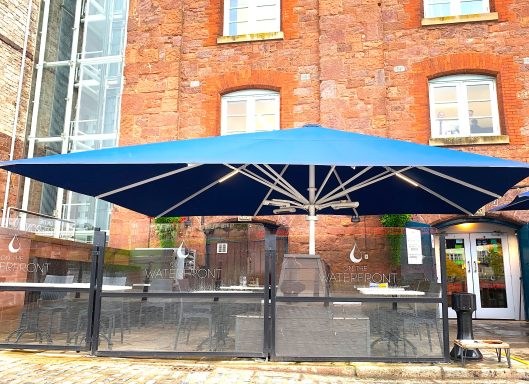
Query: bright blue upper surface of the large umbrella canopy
xmin=4 ymin=126 xmax=529 ymax=169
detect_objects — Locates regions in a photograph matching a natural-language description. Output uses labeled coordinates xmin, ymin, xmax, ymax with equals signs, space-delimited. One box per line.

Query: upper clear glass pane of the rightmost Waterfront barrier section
xmin=276 ymin=227 xmax=441 ymax=298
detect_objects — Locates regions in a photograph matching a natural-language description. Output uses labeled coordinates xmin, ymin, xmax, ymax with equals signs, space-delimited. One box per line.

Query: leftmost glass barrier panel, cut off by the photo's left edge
xmin=0 ymin=228 xmax=92 ymax=349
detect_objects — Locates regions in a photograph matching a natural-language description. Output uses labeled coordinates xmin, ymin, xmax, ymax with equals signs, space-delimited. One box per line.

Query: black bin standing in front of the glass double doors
xmin=450 ymin=292 xmax=483 ymax=360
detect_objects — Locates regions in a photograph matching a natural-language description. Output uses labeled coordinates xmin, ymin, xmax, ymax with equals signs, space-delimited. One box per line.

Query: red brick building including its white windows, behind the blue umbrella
xmin=3 ymin=0 xmax=529 ymax=324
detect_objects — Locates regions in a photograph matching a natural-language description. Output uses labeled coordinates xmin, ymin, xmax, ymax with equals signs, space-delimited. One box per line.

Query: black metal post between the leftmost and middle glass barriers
xmin=86 ymin=228 xmax=106 ymax=355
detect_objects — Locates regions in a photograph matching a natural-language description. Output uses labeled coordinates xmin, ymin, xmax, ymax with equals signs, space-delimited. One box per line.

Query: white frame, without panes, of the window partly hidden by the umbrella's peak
xmin=220 ymin=89 xmax=280 ymax=135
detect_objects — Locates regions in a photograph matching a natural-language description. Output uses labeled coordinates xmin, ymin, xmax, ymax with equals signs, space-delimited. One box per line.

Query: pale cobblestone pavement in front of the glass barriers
xmin=0 ymin=351 xmax=529 ymax=384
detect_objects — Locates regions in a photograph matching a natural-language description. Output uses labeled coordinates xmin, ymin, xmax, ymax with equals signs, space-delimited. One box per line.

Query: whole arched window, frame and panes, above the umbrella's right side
xmin=429 ymin=75 xmax=500 ymax=137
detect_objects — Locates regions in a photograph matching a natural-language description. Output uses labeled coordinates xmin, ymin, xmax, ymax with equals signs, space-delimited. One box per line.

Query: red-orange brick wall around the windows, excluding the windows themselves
xmin=111 ymin=0 xmax=529 ymax=252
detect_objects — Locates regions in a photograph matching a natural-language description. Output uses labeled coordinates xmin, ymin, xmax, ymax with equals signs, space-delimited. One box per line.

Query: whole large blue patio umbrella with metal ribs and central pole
xmin=0 ymin=126 xmax=529 ymax=254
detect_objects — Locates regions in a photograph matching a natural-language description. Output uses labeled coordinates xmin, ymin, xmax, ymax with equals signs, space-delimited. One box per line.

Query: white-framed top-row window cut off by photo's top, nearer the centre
xmin=224 ymin=0 xmax=281 ymax=36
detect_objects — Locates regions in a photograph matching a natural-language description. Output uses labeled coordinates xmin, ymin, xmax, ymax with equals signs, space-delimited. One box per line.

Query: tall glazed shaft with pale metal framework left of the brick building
xmin=22 ymin=0 xmax=129 ymax=242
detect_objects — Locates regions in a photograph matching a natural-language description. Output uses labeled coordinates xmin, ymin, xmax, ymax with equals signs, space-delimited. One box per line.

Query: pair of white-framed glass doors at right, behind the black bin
xmin=446 ymin=233 xmax=514 ymax=319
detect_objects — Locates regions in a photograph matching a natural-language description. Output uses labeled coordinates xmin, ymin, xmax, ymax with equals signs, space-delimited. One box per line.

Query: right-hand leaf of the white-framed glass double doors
xmin=470 ymin=234 xmax=514 ymax=319
